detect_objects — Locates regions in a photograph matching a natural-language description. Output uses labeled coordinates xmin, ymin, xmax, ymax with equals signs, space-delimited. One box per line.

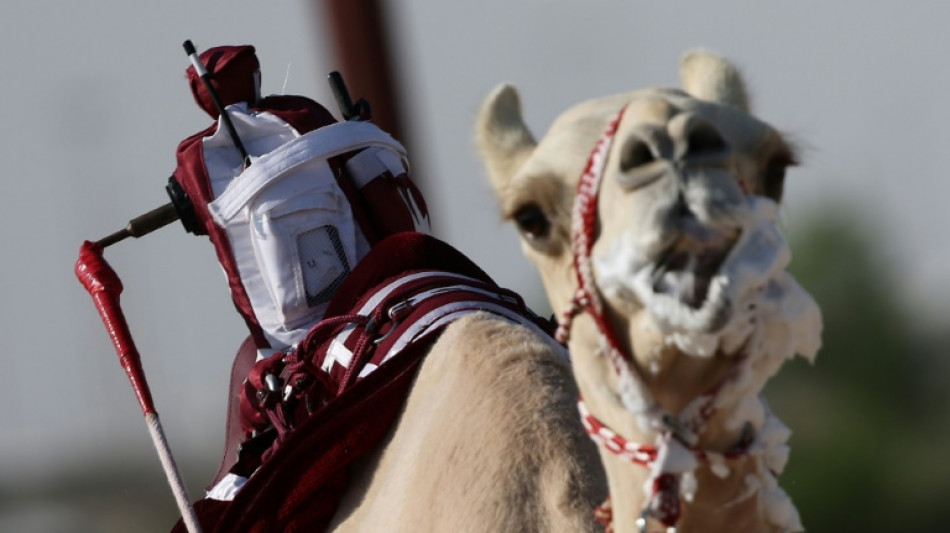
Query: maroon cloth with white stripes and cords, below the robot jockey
xmin=240 ymin=233 xmax=531 ymax=443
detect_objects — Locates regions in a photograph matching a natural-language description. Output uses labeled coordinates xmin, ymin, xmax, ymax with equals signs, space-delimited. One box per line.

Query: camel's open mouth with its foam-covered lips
xmin=595 ymin=197 xmax=791 ymax=342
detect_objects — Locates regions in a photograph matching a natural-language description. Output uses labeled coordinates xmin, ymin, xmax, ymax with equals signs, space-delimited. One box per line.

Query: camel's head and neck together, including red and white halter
xmin=475 ymin=50 xmax=821 ymax=533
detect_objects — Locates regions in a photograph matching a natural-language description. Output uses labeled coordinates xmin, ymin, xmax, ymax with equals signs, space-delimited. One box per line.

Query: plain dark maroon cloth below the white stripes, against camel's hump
xmin=172 ymin=353 xmax=422 ymax=533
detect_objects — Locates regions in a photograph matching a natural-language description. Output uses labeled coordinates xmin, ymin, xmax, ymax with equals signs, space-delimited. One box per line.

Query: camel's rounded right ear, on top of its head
xmin=680 ymin=50 xmax=749 ymax=113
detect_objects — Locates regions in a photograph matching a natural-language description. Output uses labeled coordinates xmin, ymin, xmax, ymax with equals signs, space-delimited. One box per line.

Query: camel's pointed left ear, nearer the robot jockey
xmin=475 ymin=84 xmax=537 ymax=195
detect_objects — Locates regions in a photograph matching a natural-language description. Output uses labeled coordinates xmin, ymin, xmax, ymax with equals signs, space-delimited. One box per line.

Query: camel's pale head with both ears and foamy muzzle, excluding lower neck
xmin=476 ymin=51 xmax=820 ymax=531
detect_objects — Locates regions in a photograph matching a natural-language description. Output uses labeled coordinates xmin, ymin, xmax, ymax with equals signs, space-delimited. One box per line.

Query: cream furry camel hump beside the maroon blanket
xmin=331 ymin=314 xmax=606 ymax=533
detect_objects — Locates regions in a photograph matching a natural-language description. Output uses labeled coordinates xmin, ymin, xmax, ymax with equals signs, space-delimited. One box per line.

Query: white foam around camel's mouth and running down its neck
xmin=594 ymin=197 xmax=822 ymax=531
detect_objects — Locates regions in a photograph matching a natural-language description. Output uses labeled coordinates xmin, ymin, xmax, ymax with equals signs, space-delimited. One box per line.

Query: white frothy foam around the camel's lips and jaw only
xmin=594 ymin=196 xmax=821 ymax=357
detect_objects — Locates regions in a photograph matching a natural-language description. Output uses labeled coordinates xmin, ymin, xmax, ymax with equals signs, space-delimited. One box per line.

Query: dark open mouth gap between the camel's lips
xmin=650 ymin=233 xmax=740 ymax=310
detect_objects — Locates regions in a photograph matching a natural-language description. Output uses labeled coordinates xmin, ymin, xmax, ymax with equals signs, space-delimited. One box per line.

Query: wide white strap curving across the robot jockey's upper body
xmin=208 ymin=121 xmax=406 ymax=226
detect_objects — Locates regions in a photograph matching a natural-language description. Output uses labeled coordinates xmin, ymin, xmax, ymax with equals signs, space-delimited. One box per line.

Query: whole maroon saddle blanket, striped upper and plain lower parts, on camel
xmin=173 ymin=233 xmax=549 ymax=533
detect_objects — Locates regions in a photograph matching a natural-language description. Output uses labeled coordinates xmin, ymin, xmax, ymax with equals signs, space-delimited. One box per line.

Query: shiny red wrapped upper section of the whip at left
xmin=75 ymin=241 xmax=155 ymax=415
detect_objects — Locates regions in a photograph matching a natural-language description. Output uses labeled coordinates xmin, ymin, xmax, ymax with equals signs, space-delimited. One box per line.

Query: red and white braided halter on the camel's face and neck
xmin=555 ymin=106 xmax=746 ymax=532
